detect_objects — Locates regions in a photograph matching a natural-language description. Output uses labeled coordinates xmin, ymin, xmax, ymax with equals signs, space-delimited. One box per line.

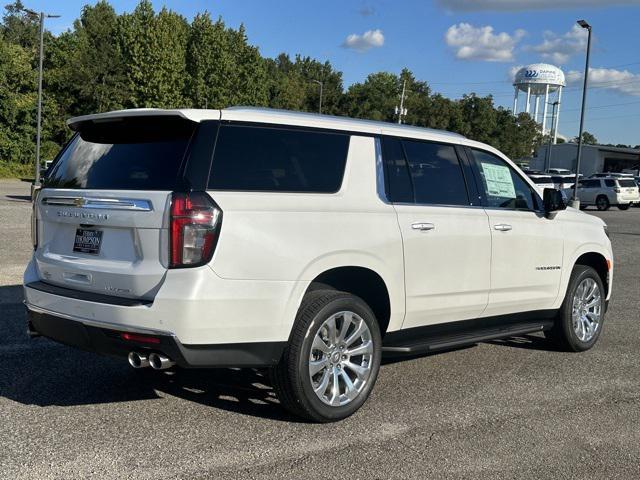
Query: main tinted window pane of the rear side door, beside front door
xmin=402 ymin=140 xmax=469 ymax=205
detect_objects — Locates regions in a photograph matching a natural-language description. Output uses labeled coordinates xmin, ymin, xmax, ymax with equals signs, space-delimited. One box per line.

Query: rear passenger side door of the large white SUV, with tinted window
xmin=382 ymin=137 xmax=491 ymax=328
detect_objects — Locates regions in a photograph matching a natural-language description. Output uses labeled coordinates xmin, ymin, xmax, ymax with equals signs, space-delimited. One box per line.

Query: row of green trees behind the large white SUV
xmin=0 ymin=0 xmax=541 ymax=169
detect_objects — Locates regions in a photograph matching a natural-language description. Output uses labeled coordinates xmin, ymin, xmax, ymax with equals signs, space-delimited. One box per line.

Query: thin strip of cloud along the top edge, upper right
xmin=438 ymin=0 xmax=640 ymax=12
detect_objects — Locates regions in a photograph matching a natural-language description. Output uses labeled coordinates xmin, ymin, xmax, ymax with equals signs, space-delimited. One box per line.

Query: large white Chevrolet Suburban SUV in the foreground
xmin=24 ymin=108 xmax=613 ymax=422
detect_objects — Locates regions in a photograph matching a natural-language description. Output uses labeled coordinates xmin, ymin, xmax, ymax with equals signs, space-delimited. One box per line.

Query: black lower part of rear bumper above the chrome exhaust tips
xmin=27 ymin=305 xmax=286 ymax=368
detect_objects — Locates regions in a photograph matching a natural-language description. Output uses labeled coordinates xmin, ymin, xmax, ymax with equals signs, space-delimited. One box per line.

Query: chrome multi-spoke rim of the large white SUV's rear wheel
xmin=309 ymin=311 xmax=373 ymax=407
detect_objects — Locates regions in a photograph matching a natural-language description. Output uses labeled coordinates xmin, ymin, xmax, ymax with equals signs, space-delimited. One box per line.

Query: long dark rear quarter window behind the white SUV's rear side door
xmin=209 ymin=125 xmax=349 ymax=193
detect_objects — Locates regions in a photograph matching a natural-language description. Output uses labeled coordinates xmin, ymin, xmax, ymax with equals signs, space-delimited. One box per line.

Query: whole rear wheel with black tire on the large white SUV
xmin=271 ymin=290 xmax=382 ymax=423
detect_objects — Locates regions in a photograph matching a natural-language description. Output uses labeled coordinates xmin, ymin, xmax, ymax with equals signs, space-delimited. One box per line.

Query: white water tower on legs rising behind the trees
xmin=513 ymin=63 xmax=566 ymax=144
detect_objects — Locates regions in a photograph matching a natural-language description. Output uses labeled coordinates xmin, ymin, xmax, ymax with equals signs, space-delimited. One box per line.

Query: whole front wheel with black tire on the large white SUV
xmin=545 ymin=265 xmax=606 ymax=352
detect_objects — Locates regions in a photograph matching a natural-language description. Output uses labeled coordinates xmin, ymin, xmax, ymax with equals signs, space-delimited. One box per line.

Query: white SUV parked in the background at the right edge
xmin=564 ymin=177 xmax=640 ymax=210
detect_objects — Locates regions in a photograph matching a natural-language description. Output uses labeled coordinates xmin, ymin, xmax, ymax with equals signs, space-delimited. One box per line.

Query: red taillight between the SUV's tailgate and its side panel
xmin=169 ymin=192 xmax=222 ymax=268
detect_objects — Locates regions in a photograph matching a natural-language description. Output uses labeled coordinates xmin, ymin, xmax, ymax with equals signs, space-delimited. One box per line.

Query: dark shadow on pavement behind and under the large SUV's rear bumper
xmin=0 ymin=285 xmax=298 ymax=422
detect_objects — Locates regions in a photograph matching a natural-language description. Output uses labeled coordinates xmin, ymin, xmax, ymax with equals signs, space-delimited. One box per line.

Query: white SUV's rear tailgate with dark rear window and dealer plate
xmin=35 ymin=117 xmax=210 ymax=298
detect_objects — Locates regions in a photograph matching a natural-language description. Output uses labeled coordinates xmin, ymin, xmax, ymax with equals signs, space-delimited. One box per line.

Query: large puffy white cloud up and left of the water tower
xmin=444 ymin=23 xmax=526 ymax=62
